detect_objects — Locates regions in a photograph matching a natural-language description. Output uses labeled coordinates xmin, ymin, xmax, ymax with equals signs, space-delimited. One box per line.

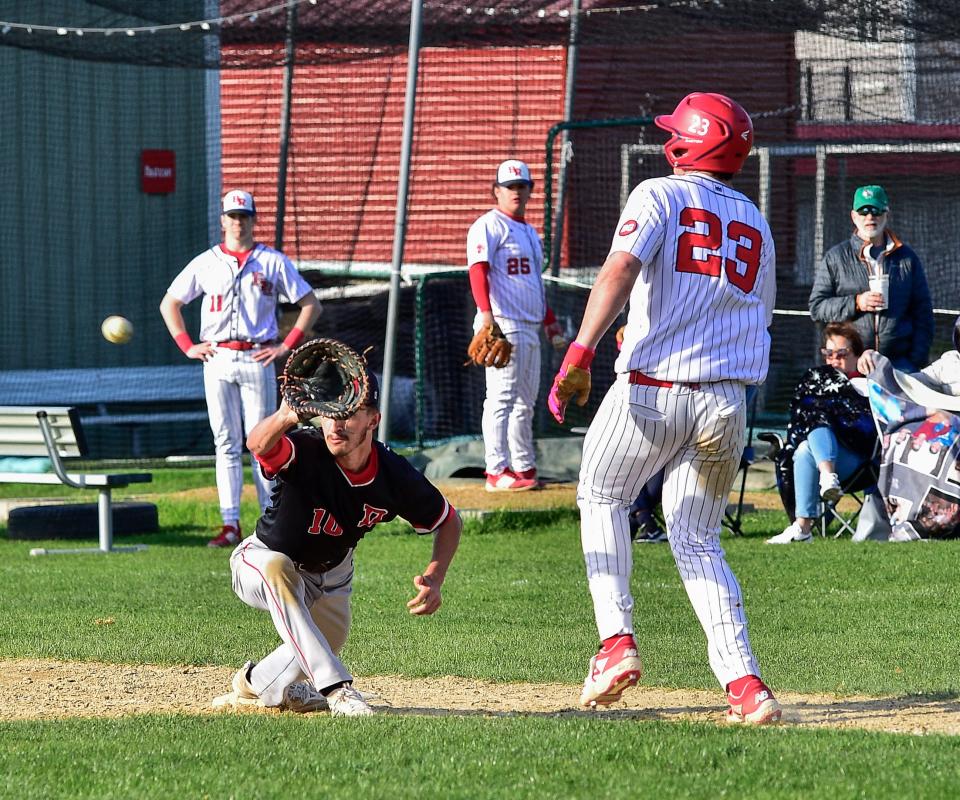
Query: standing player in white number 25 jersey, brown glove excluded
xmin=467 ymin=159 xmax=567 ymax=492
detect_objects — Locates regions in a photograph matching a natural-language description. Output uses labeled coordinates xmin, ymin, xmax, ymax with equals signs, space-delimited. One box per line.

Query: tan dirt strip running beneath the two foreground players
xmin=0 ymin=659 xmax=960 ymax=735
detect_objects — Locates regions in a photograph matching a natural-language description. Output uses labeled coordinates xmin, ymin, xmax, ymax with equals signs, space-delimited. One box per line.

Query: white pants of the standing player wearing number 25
xmin=481 ymin=320 xmax=540 ymax=475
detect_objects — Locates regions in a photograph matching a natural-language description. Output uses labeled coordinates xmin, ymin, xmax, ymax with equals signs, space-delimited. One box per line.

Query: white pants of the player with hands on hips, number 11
xmin=203 ymin=347 xmax=277 ymax=523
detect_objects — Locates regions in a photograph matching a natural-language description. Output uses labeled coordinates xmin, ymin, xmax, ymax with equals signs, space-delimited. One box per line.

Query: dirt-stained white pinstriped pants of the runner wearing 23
xmin=577 ymin=374 xmax=760 ymax=687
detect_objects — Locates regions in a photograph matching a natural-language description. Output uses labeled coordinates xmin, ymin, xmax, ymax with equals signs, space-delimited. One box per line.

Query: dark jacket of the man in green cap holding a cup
xmin=810 ymin=231 xmax=933 ymax=370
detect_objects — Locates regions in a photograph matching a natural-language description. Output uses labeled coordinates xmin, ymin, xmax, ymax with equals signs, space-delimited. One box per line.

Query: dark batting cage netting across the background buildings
xmin=0 ymin=0 xmax=960 ymax=459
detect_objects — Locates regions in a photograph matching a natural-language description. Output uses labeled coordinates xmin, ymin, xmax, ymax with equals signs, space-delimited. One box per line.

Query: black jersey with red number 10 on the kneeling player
xmin=257 ymin=428 xmax=450 ymax=572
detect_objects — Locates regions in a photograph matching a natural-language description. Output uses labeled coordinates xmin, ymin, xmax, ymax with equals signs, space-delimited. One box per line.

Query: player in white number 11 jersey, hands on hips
xmin=160 ymin=191 xmax=320 ymax=547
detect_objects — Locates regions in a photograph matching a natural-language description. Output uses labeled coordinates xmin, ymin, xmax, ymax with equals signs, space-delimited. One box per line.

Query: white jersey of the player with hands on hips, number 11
xmin=167 ymin=243 xmax=312 ymax=342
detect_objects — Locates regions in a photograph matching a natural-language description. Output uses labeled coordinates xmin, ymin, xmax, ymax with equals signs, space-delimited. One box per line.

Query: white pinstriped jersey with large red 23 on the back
xmin=610 ymin=174 xmax=776 ymax=384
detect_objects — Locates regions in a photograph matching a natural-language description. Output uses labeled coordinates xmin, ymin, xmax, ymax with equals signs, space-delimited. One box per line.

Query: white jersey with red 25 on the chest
xmin=467 ymin=208 xmax=546 ymax=322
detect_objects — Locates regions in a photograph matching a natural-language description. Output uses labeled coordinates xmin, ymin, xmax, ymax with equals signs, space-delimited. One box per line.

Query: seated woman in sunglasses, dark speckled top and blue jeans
xmin=767 ymin=322 xmax=877 ymax=544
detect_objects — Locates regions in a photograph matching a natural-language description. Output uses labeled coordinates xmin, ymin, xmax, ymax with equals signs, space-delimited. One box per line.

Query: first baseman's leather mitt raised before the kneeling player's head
xmin=281 ymin=339 xmax=370 ymax=422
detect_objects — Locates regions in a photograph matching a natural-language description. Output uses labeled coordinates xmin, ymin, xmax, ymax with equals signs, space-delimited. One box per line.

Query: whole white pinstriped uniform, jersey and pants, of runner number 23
xmin=577 ymin=175 xmax=776 ymax=687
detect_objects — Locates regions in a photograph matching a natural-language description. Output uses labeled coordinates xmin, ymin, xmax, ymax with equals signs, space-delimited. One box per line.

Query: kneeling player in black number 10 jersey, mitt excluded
xmin=214 ymin=374 xmax=461 ymax=716
